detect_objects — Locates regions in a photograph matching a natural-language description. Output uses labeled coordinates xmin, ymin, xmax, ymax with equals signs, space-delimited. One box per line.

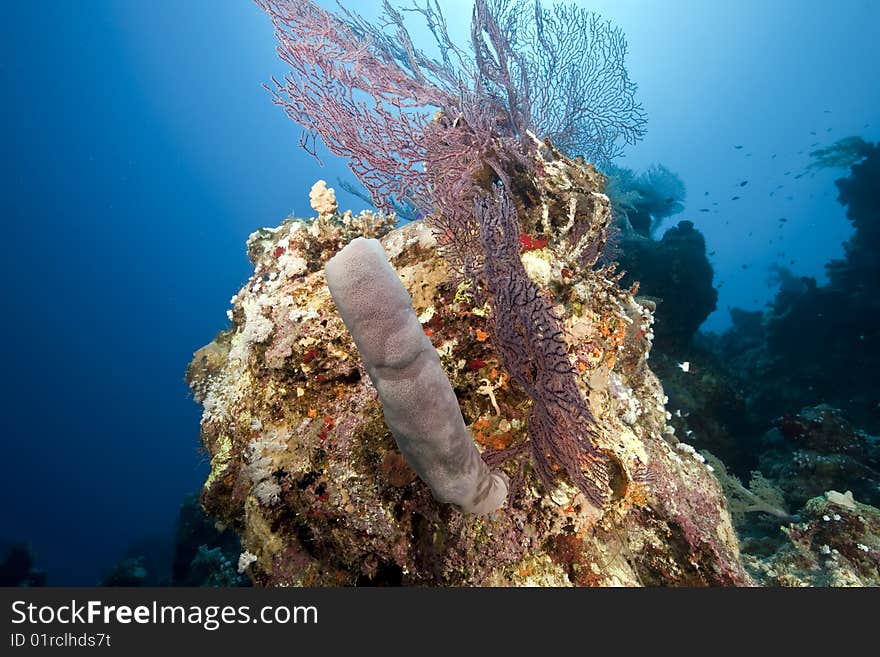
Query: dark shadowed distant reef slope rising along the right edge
xmin=714 ymin=144 xmax=880 ymax=432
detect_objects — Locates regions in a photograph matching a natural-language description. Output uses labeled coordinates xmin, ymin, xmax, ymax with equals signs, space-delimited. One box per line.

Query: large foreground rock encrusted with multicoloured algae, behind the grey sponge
xmin=187 ymin=160 xmax=750 ymax=586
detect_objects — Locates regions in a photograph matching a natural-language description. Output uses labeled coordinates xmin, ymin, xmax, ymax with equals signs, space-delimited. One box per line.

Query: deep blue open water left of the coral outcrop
xmin=0 ymin=0 xmax=354 ymax=584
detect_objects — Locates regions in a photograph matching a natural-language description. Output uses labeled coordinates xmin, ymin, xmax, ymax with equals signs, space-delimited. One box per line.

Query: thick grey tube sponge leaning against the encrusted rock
xmin=325 ymin=237 xmax=507 ymax=515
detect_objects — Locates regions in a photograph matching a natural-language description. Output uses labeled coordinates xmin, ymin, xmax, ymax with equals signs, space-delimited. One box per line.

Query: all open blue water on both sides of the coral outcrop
xmin=0 ymin=0 xmax=880 ymax=584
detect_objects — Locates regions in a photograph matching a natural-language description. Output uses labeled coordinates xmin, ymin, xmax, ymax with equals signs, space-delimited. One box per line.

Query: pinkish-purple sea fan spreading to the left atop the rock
xmin=257 ymin=0 xmax=509 ymax=271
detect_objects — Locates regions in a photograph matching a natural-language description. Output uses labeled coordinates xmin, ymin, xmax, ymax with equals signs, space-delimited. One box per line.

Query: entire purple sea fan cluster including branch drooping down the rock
xmin=256 ymin=0 xmax=645 ymax=505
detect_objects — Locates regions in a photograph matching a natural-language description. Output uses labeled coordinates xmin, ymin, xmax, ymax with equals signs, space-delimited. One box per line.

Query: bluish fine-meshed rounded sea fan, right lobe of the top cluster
xmin=472 ymin=0 xmax=647 ymax=166
